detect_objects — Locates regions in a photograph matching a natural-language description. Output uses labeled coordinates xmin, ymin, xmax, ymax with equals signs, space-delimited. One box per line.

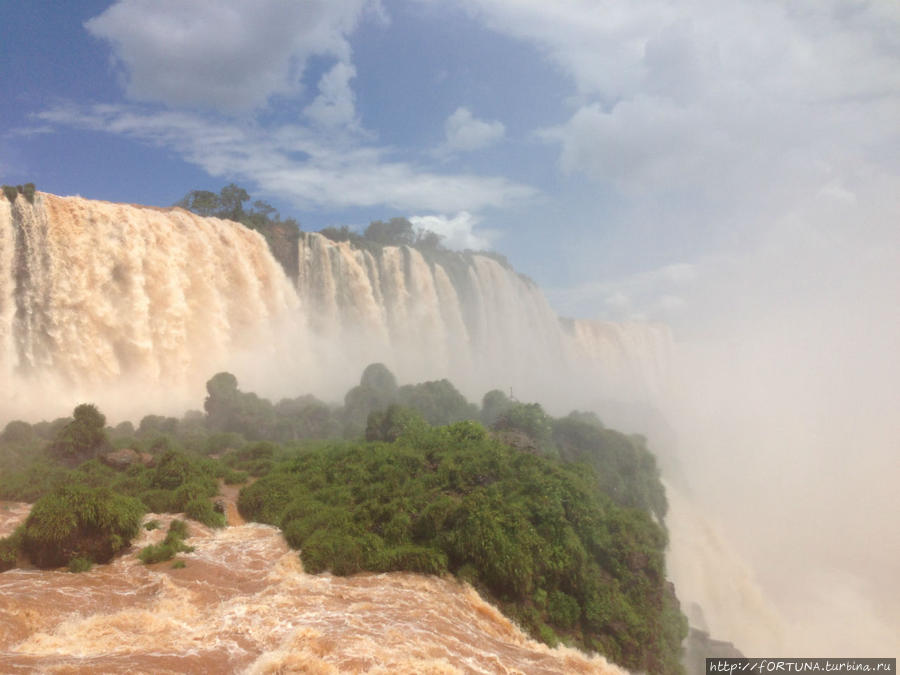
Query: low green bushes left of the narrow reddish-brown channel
xmin=0 ymin=404 xmax=226 ymax=571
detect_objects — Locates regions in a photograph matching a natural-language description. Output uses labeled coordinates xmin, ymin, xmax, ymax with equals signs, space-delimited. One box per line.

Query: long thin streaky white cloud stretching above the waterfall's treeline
xmin=37 ymin=105 xmax=536 ymax=212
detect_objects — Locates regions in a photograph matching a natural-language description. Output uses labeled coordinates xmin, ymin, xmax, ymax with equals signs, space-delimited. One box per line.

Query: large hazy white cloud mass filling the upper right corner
xmin=458 ymin=0 xmax=900 ymax=214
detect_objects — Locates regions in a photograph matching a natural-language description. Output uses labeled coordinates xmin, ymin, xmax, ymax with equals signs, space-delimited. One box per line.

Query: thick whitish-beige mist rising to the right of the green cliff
xmin=663 ymin=176 xmax=900 ymax=656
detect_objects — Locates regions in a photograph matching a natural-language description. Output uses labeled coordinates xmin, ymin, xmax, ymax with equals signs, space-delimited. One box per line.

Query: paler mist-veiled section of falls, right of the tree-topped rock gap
xmin=297 ymin=233 xmax=671 ymax=407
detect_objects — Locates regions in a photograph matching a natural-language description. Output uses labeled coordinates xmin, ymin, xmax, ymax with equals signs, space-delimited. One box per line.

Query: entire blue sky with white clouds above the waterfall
xmin=0 ymin=0 xmax=900 ymax=326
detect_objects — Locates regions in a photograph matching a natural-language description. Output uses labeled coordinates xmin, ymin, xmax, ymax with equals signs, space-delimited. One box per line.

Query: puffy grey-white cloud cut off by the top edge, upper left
xmin=85 ymin=0 xmax=379 ymax=111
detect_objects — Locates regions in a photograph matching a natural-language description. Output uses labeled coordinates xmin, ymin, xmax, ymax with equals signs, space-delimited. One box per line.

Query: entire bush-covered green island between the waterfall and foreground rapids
xmin=0 ymin=364 xmax=687 ymax=673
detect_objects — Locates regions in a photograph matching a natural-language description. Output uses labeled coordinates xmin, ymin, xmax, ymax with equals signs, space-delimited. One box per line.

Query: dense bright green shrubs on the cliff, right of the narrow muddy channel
xmin=239 ymin=421 xmax=686 ymax=673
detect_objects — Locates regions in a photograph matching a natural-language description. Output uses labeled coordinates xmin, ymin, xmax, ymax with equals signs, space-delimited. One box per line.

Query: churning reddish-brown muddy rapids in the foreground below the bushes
xmin=0 ymin=500 xmax=625 ymax=675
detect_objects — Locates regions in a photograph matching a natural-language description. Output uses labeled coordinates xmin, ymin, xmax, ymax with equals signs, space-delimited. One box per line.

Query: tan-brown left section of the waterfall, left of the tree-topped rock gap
xmin=0 ymin=194 xmax=297 ymax=417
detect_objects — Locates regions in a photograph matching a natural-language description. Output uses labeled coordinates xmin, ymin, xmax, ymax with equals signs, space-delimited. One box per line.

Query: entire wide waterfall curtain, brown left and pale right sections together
xmin=0 ymin=193 xmax=671 ymax=419
